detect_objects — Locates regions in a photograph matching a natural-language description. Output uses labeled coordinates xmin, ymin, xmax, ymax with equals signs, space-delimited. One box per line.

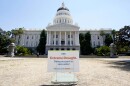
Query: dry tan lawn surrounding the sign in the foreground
xmin=0 ymin=56 xmax=130 ymax=86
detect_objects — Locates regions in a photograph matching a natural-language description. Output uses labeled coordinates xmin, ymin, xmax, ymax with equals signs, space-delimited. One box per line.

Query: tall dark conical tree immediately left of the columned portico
xmin=37 ymin=30 xmax=46 ymax=55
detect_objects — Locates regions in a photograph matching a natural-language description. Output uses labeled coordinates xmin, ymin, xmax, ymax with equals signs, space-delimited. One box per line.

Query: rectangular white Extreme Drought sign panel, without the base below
xmin=48 ymin=50 xmax=79 ymax=72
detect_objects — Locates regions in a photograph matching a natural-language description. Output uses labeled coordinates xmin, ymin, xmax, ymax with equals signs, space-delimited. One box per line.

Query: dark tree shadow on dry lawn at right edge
xmin=109 ymin=60 xmax=130 ymax=71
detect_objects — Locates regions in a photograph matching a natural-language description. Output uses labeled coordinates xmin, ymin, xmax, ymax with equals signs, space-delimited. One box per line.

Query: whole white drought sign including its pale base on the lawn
xmin=48 ymin=50 xmax=79 ymax=83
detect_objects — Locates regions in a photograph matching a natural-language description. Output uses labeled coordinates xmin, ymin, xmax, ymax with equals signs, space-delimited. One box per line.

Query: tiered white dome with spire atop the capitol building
xmin=53 ymin=3 xmax=73 ymax=24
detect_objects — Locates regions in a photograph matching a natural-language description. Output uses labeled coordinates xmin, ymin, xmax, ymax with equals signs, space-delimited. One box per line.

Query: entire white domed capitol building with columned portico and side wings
xmin=16 ymin=3 xmax=112 ymax=54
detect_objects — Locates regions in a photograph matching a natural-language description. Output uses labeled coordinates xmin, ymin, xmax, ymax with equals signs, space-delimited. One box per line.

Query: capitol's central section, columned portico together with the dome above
xmin=46 ymin=3 xmax=80 ymax=54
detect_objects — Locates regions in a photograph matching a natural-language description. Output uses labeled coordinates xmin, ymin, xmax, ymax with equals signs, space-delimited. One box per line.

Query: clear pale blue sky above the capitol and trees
xmin=0 ymin=0 xmax=130 ymax=31
